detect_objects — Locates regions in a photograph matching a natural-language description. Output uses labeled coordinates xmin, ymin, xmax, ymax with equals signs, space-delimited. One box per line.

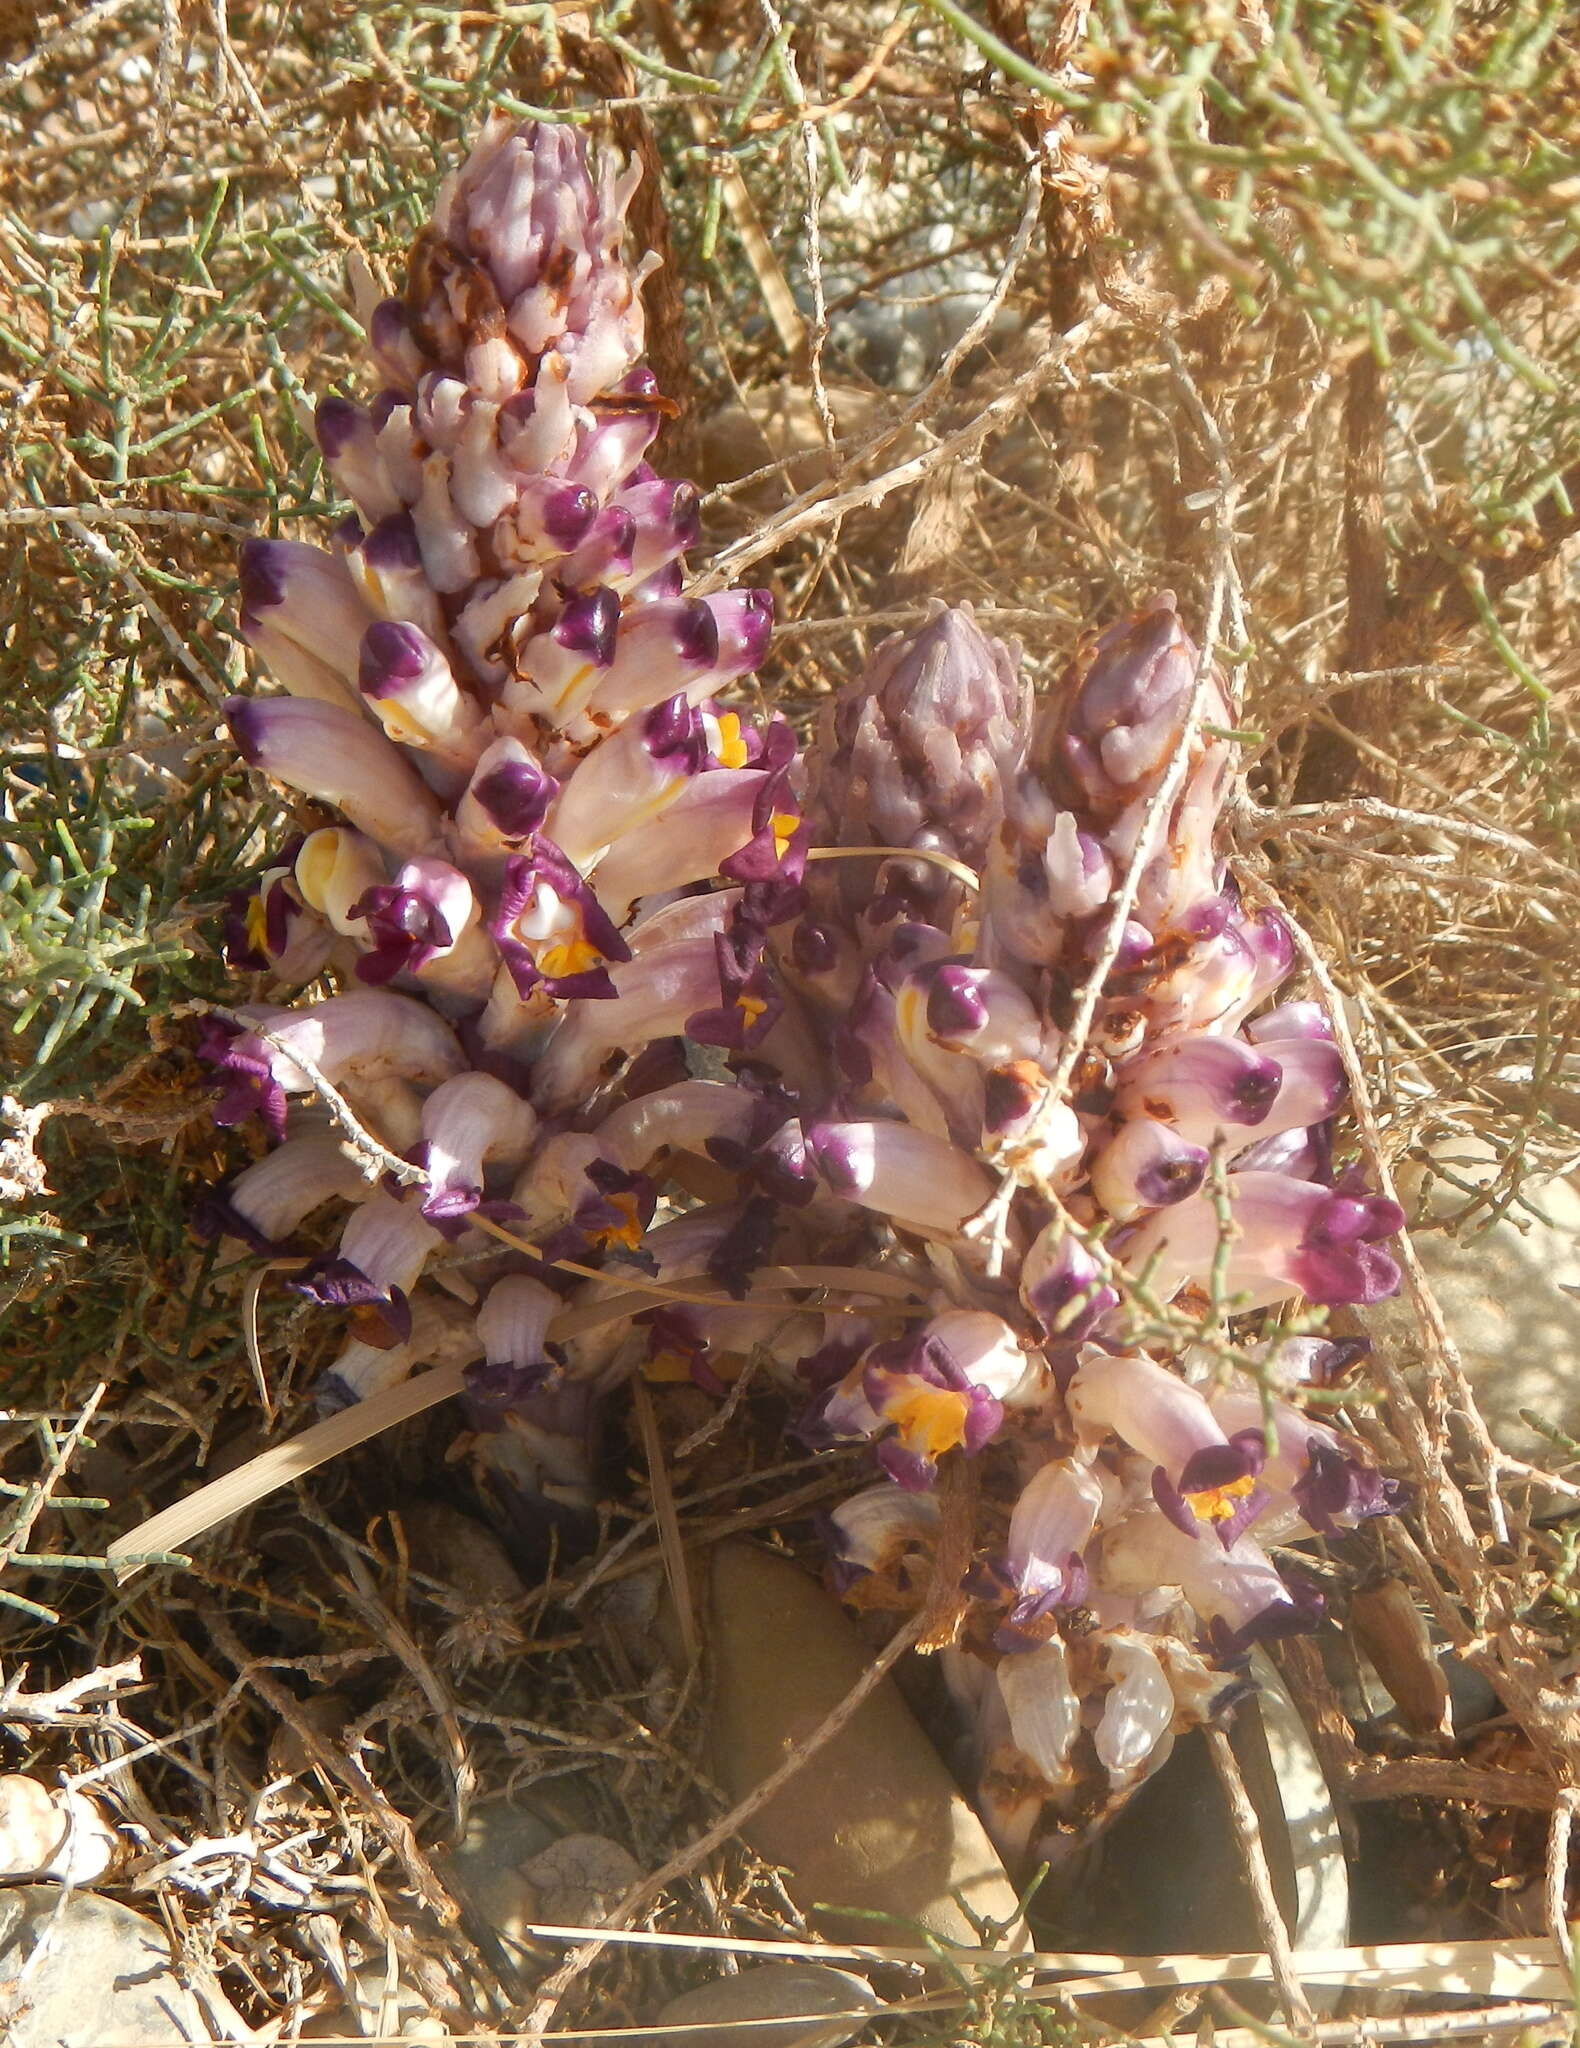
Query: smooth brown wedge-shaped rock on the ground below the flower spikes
xmin=707 ymin=1542 xmax=1018 ymax=1948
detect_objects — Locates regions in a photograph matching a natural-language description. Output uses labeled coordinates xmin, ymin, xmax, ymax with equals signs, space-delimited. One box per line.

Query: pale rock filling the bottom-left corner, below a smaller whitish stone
xmin=0 ymin=1884 xmax=211 ymax=2048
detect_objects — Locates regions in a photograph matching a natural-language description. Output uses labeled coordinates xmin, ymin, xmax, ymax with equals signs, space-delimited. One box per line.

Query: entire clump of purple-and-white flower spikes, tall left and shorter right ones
xmin=203 ymin=123 xmax=1402 ymax=1853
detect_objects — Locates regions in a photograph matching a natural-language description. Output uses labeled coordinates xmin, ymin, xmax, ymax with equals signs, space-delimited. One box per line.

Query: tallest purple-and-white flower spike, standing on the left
xmin=201 ymin=119 xmax=786 ymax=1441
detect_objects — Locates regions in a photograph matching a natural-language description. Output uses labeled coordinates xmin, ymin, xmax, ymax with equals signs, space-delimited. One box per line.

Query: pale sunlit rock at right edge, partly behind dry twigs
xmin=1367 ymin=1139 xmax=1580 ymax=1464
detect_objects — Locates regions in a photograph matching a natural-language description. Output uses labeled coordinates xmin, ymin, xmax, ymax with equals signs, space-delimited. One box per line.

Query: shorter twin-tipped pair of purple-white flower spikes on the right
xmin=775 ymin=596 xmax=1404 ymax=1862
